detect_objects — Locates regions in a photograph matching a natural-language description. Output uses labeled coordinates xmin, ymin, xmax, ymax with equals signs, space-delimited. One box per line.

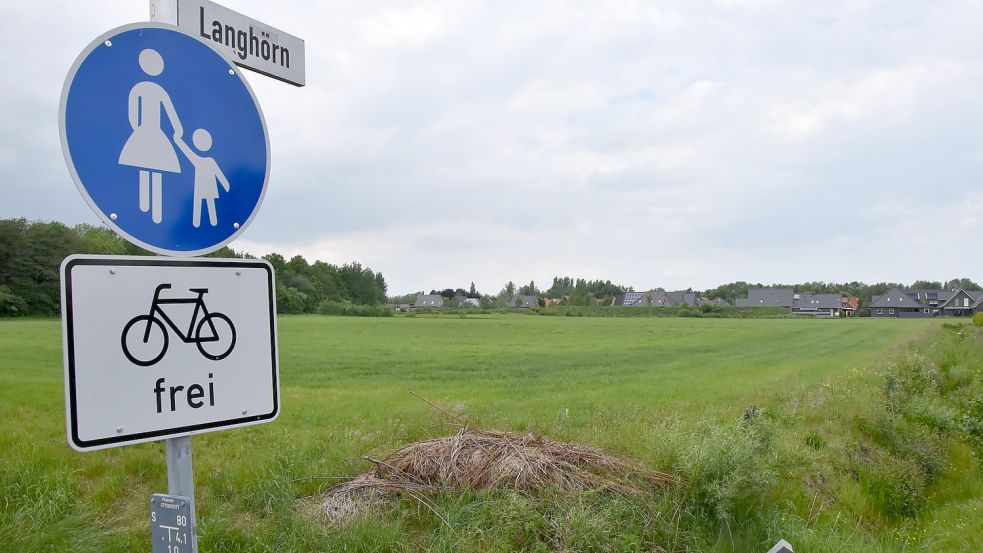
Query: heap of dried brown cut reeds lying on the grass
xmin=322 ymin=425 xmax=677 ymax=523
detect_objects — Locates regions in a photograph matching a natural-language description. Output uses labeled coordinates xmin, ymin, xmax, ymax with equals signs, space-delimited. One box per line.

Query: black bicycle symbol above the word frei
xmin=120 ymin=284 xmax=236 ymax=367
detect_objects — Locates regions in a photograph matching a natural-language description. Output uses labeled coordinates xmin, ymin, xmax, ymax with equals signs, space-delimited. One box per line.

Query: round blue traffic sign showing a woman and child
xmin=59 ymin=23 xmax=270 ymax=256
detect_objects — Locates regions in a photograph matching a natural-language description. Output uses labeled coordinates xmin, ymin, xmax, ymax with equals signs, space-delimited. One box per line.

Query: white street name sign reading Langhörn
xmin=177 ymin=0 xmax=305 ymax=86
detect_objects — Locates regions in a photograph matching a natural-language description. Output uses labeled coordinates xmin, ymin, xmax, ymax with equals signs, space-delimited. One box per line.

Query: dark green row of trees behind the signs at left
xmin=0 ymin=219 xmax=386 ymax=316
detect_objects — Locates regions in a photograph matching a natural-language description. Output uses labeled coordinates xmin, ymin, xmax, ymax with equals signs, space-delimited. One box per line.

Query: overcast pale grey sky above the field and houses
xmin=0 ymin=0 xmax=983 ymax=293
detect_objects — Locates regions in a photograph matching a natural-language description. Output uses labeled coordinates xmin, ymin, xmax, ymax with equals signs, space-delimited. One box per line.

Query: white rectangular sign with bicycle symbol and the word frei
xmin=61 ymin=255 xmax=280 ymax=451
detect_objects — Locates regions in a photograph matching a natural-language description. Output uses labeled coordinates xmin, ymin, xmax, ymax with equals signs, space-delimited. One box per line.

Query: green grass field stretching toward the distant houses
xmin=0 ymin=315 xmax=983 ymax=551
